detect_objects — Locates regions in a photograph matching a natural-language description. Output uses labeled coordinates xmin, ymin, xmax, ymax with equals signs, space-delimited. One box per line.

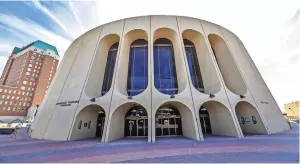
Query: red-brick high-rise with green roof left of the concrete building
xmin=0 ymin=40 xmax=59 ymax=122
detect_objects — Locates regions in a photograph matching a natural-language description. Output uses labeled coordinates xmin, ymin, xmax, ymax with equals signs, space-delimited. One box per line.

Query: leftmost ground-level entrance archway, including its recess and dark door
xmin=70 ymin=104 xmax=105 ymax=140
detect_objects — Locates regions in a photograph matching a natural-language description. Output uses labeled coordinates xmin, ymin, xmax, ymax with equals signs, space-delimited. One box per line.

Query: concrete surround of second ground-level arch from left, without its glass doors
xmin=105 ymin=102 xmax=151 ymax=142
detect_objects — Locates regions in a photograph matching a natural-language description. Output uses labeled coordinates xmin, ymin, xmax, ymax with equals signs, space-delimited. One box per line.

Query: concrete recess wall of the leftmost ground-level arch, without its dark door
xmin=69 ymin=104 xmax=107 ymax=140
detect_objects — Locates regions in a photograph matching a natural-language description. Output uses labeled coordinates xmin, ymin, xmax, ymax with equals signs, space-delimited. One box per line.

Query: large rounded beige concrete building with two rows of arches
xmin=31 ymin=16 xmax=289 ymax=142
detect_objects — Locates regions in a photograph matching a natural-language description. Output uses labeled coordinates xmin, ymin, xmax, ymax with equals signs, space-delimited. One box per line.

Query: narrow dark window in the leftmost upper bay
xmin=101 ymin=43 xmax=119 ymax=96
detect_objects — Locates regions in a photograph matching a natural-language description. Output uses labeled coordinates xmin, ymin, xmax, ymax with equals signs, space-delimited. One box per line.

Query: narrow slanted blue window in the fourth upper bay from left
xmin=183 ymin=39 xmax=204 ymax=92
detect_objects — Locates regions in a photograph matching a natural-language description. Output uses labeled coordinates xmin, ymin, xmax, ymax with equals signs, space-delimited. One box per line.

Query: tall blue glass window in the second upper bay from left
xmin=127 ymin=39 xmax=148 ymax=96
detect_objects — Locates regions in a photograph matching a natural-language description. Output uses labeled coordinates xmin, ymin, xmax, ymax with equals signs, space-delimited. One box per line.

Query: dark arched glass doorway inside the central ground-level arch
xmin=155 ymin=105 xmax=182 ymax=136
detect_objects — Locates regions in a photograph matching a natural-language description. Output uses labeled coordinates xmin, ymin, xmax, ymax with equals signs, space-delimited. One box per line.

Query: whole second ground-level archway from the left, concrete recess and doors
xmin=106 ymin=102 xmax=151 ymax=142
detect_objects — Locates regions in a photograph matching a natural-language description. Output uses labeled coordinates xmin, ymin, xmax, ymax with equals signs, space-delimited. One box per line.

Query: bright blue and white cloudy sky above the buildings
xmin=0 ymin=0 xmax=300 ymax=109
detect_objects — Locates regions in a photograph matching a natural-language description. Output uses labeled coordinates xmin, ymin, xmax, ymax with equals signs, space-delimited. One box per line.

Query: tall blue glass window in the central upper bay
xmin=153 ymin=38 xmax=178 ymax=95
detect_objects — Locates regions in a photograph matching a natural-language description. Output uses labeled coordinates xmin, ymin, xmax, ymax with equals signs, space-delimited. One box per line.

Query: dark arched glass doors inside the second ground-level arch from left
xmin=124 ymin=106 xmax=148 ymax=137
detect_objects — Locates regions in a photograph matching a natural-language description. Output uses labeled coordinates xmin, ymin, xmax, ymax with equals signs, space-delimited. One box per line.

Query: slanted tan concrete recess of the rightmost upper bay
xmin=208 ymin=34 xmax=247 ymax=95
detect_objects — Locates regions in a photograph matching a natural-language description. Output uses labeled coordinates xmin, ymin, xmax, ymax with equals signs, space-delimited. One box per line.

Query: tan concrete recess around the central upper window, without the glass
xmin=151 ymin=28 xmax=188 ymax=94
